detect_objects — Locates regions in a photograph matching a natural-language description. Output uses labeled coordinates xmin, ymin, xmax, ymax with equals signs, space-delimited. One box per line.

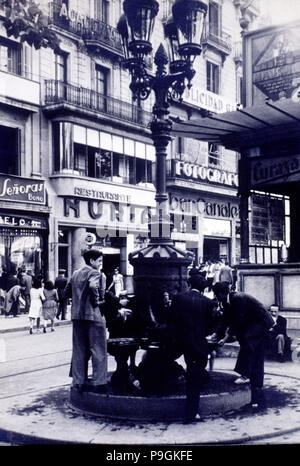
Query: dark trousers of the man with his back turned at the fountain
xmin=184 ymin=352 xmax=208 ymax=420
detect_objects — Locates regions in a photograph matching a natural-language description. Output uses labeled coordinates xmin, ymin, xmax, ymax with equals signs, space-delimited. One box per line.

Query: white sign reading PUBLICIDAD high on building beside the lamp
xmin=183 ymin=86 xmax=237 ymax=113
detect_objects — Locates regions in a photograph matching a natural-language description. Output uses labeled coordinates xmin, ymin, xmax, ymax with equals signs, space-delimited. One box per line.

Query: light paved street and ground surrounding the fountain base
xmin=0 ymin=322 xmax=300 ymax=445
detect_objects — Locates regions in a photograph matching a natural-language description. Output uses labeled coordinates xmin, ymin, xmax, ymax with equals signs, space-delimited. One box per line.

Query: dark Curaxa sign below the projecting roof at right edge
xmin=249 ymin=154 xmax=300 ymax=186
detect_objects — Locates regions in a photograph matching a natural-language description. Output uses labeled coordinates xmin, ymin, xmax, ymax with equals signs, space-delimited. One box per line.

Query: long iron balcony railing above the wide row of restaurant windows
xmin=45 ymin=79 xmax=152 ymax=127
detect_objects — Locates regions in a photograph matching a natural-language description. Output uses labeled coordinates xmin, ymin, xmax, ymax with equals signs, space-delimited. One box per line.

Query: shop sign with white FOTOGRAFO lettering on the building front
xmin=175 ymin=160 xmax=238 ymax=187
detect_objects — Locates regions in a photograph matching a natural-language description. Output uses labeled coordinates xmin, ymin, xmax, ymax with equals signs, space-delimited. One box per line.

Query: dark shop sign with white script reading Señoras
xmin=0 ymin=175 xmax=46 ymax=204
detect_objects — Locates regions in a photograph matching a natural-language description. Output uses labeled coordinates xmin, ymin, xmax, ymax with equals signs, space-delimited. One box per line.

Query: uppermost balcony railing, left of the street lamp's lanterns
xmin=49 ymin=2 xmax=123 ymax=55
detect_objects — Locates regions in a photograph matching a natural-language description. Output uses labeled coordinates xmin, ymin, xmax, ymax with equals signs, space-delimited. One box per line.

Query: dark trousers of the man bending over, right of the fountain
xmin=234 ymin=338 xmax=265 ymax=403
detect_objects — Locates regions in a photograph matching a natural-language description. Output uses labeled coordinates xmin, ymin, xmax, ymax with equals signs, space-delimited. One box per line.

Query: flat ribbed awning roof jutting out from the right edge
xmin=172 ymin=99 xmax=300 ymax=150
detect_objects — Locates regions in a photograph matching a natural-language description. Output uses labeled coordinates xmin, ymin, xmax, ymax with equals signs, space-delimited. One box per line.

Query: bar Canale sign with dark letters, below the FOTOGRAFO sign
xmin=170 ymin=194 xmax=239 ymax=219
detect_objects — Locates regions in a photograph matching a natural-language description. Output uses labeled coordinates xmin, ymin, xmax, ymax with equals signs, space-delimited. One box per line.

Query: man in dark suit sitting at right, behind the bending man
xmin=268 ymin=304 xmax=290 ymax=362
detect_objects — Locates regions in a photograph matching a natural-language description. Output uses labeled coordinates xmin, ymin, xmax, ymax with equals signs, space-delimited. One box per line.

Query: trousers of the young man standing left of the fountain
xmin=72 ymin=318 xmax=107 ymax=385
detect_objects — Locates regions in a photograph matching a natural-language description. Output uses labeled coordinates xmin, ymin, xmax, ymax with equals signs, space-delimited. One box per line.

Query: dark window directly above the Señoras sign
xmin=0 ymin=126 xmax=20 ymax=175
